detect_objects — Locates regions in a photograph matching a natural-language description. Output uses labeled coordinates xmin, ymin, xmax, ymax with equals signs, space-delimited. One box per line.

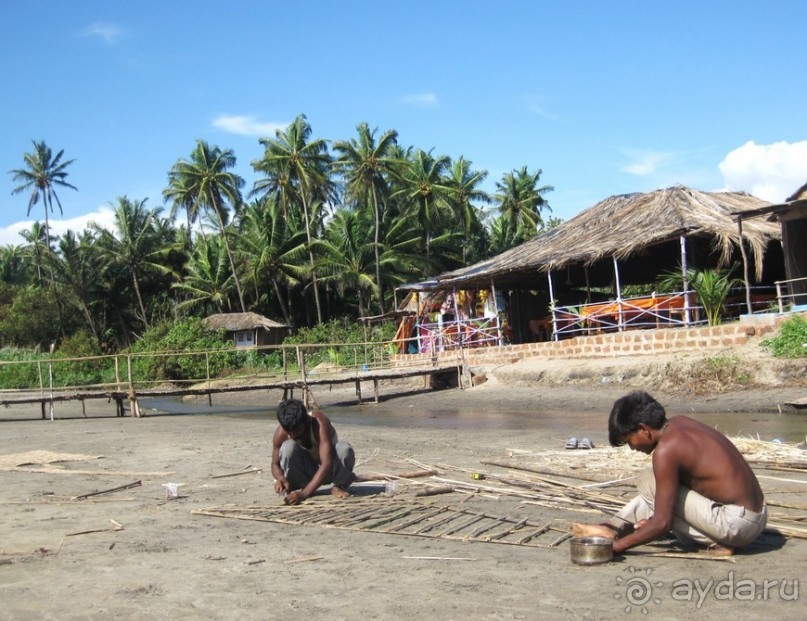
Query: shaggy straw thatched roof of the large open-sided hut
xmin=437 ymin=186 xmax=781 ymax=286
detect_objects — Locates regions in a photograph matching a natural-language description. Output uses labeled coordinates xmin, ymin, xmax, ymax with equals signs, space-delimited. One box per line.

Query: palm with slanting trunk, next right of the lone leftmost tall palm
xmin=93 ymin=196 xmax=171 ymax=329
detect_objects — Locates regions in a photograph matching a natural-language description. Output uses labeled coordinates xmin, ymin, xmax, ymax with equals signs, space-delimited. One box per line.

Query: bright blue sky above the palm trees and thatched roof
xmin=0 ymin=0 xmax=807 ymax=244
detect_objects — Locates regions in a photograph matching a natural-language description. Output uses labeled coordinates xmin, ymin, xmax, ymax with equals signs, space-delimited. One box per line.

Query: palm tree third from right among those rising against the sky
xmin=396 ymin=149 xmax=450 ymax=263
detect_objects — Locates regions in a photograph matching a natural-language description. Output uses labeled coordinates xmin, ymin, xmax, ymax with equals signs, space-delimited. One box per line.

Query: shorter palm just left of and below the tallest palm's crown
xmin=239 ymin=196 xmax=306 ymax=325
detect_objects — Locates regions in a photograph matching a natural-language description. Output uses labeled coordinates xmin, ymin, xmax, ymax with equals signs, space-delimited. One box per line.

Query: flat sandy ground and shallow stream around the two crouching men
xmin=0 ymin=360 xmax=807 ymax=620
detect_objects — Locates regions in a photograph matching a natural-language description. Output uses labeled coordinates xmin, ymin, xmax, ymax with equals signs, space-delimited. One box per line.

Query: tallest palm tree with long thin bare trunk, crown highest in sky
xmin=251 ymin=114 xmax=333 ymax=323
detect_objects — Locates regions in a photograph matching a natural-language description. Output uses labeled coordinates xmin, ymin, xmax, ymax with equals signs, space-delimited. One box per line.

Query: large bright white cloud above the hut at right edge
xmin=718 ymin=140 xmax=807 ymax=203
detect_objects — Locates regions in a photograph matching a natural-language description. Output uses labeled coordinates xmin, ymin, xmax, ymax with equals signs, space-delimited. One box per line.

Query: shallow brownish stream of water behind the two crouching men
xmin=143 ymin=399 xmax=807 ymax=443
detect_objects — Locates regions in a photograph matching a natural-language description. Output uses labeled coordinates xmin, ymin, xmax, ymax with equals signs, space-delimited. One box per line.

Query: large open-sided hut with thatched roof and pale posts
xmin=404 ymin=186 xmax=784 ymax=343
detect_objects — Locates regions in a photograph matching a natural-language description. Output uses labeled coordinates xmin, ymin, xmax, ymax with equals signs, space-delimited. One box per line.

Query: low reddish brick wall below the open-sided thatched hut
xmin=392 ymin=318 xmax=782 ymax=366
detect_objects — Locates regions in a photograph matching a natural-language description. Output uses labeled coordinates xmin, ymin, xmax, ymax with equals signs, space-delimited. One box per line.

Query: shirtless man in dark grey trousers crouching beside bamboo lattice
xmin=272 ymin=399 xmax=356 ymax=505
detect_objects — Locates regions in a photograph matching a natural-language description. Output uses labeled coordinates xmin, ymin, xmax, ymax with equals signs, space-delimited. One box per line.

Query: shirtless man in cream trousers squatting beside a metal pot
xmin=571 ymin=391 xmax=768 ymax=554
